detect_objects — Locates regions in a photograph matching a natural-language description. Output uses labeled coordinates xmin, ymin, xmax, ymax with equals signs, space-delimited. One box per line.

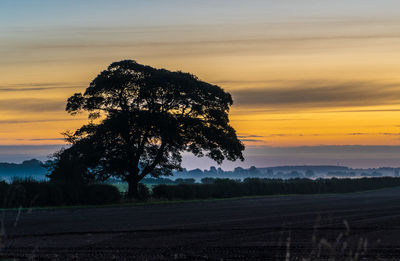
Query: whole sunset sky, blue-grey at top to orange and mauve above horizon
xmin=0 ymin=0 xmax=400 ymax=168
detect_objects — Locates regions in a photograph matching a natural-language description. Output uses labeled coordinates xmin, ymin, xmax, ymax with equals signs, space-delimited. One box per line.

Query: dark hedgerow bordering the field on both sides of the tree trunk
xmin=0 ymin=177 xmax=400 ymax=208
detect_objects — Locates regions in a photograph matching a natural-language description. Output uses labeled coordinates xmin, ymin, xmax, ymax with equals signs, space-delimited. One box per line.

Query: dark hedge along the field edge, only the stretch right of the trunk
xmin=152 ymin=177 xmax=400 ymax=200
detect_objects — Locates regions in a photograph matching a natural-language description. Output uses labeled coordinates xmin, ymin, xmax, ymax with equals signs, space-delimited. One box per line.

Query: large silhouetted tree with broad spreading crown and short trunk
xmin=51 ymin=60 xmax=244 ymax=197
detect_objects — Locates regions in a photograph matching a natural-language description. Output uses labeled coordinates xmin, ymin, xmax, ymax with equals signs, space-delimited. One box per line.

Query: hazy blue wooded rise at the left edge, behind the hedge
xmin=0 ymin=159 xmax=46 ymax=176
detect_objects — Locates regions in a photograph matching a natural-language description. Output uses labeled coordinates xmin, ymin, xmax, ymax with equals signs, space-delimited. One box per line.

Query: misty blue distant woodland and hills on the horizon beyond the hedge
xmin=0 ymin=159 xmax=400 ymax=180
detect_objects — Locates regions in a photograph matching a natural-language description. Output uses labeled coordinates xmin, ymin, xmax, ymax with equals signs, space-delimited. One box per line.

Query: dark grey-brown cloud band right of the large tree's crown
xmin=233 ymin=82 xmax=400 ymax=110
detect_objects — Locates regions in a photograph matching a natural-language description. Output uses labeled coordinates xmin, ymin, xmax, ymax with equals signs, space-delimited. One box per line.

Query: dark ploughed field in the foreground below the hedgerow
xmin=1 ymin=188 xmax=400 ymax=260
